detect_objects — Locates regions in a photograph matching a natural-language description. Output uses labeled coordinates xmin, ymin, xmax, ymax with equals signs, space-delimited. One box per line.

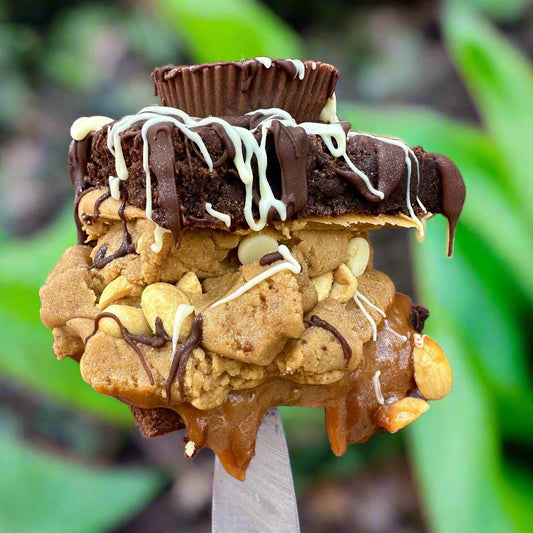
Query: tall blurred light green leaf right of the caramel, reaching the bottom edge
xmin=409 ymin=222 xmax=516 ymax=532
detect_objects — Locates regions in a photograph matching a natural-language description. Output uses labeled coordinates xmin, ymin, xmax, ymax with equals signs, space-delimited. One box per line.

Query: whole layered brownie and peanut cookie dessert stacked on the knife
xmin=41 ymin=58 xmax=465 ymax=479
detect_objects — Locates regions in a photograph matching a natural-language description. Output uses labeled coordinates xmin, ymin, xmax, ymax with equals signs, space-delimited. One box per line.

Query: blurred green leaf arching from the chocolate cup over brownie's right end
xmin=339 ymin=102 xmax=533 ymax=301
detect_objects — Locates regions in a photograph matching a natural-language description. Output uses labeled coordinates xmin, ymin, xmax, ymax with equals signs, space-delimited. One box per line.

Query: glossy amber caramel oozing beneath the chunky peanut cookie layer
xmin=175 ymin=295 xmax=416 ymax=480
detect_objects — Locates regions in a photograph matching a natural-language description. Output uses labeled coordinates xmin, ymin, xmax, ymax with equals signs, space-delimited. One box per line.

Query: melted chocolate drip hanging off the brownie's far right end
xmin=433 ymin=154 xmax=466 ymax=257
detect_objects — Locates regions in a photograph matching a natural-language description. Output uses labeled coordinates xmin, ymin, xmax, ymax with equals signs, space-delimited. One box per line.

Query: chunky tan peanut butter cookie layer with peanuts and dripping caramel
xmin=41 ymin=189 xmax=451 ymax=479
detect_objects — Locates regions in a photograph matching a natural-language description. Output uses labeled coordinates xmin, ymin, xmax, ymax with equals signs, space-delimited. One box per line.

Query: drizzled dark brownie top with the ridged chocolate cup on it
xmin=69 ymin=58 xmax=465 ymax=255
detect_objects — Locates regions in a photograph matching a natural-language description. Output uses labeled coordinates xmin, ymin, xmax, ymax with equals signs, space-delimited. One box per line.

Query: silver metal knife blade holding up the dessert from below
xmin=212 ymin=407 xmax=300 ymax=533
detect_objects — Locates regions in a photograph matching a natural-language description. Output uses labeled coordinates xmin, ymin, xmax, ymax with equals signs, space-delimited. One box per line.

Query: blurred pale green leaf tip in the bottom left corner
xmin=0 ymin=433 xmax=163 ymax=533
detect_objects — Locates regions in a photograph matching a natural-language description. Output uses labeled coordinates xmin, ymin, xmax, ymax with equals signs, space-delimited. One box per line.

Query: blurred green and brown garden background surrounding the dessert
xmin=0 ymin=0 xmax=533 ymax=533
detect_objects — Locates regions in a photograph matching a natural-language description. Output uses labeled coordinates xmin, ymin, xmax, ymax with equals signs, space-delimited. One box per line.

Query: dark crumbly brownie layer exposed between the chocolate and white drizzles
xmin=80 ymin=123 xmax=444 ymax=230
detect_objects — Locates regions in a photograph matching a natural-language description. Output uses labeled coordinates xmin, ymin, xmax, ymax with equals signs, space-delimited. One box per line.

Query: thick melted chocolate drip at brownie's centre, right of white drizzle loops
xmin=270 ymin=120 xmax=309 ymax=218
